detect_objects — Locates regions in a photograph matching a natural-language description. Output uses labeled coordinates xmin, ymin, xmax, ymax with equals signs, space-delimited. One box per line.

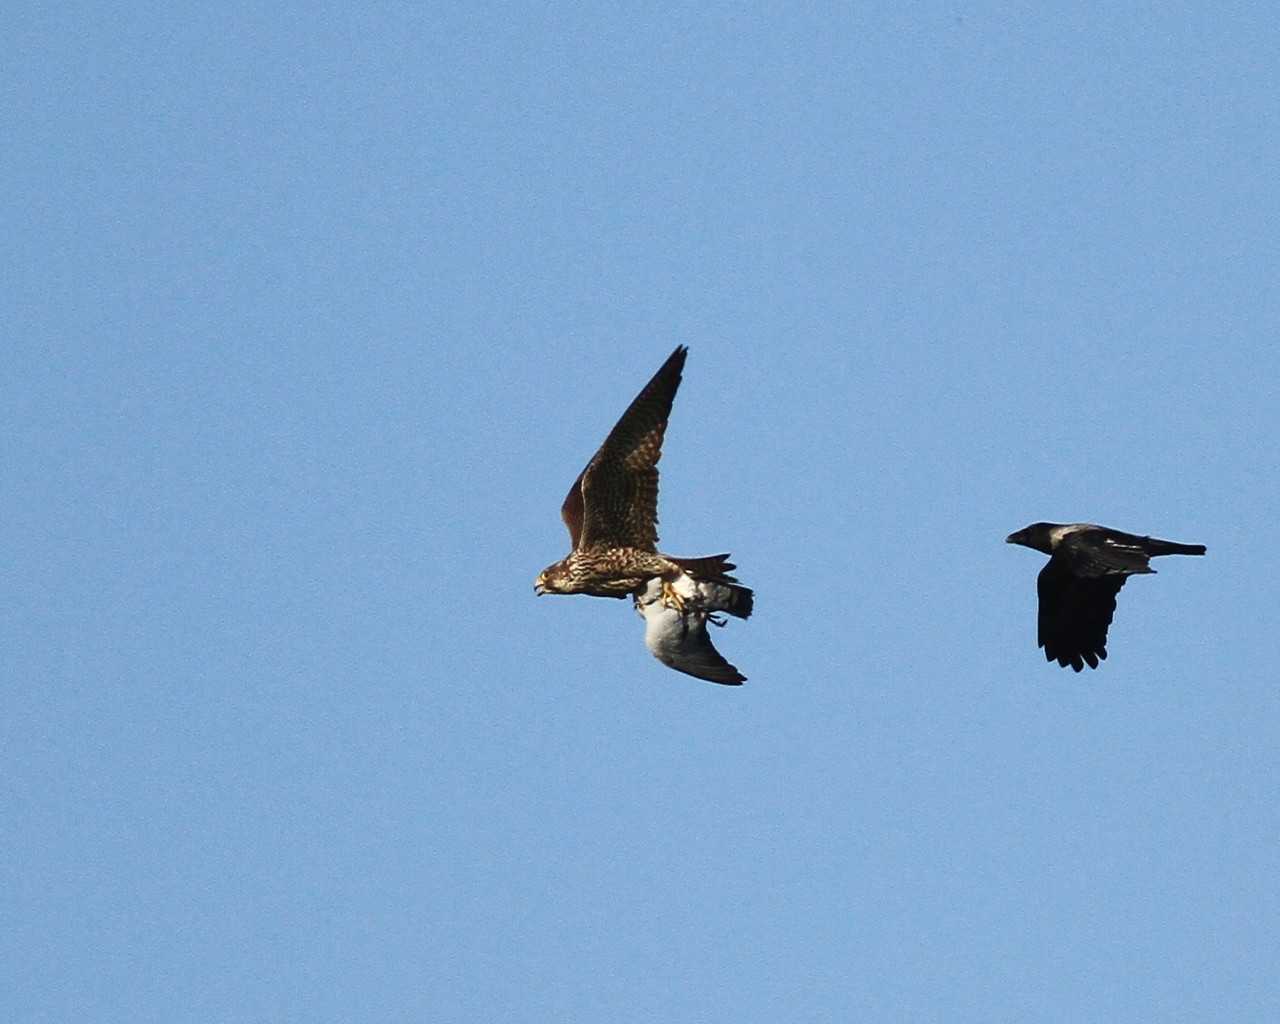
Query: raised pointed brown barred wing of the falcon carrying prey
xmin=561 ymin=346 xmax=689 ymax=550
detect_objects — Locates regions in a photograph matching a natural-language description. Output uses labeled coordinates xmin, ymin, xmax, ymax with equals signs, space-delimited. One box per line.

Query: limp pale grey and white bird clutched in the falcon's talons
xmin=635 ymin=573 xmax=751 ymax=686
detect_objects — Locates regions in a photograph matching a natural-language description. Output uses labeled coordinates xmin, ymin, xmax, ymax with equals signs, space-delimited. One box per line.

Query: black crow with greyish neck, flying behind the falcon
xmin=1005 ymin=522 xmax=1204 ymax=672
